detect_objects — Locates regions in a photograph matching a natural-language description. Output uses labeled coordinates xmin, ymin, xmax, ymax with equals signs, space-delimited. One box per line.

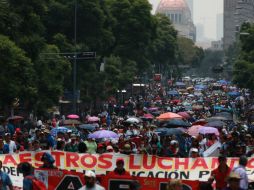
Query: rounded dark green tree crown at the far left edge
xmin=0 ymin=35 xmax=37 ymax=113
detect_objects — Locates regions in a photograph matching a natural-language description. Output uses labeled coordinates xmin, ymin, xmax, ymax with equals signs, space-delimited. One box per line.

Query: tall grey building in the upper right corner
xmin=223 ymin=0 xmax=254 ymax=49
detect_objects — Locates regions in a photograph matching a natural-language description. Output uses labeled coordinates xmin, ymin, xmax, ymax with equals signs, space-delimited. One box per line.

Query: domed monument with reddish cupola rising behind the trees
xmin=156 ymin=0 xmax=196 ymax=42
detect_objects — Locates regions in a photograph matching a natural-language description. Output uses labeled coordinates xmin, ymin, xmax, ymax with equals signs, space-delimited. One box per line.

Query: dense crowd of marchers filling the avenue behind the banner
xmin=0 ymin=77 xmax=254 ymax=189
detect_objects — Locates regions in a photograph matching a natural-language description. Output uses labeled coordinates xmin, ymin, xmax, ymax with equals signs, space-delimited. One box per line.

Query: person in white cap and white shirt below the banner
xmin=79 ymin=170 xmax=105 ymax=190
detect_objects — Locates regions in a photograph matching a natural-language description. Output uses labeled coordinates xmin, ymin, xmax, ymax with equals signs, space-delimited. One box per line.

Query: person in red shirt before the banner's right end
xmin=211 ymin=155 xmax=231 ymax=190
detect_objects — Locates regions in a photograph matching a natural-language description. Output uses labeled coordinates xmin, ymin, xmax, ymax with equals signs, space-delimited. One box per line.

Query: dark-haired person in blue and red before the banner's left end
xmin=18 ymin=162 xmax=47 ymax=190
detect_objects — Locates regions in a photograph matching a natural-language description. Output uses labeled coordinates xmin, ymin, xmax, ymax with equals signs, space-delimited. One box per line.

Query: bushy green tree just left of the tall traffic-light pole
xmin=34 ymin=45 xmax=71 ymax=114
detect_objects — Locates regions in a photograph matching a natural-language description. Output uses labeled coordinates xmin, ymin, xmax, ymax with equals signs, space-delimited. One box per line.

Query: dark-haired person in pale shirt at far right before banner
xmin=232 ymin=156 xmax=249 ymax=190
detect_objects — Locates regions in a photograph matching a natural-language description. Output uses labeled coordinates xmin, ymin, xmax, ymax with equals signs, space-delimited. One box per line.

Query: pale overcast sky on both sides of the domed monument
xmin=149 ymin=0 xmax=223 ymax=39
